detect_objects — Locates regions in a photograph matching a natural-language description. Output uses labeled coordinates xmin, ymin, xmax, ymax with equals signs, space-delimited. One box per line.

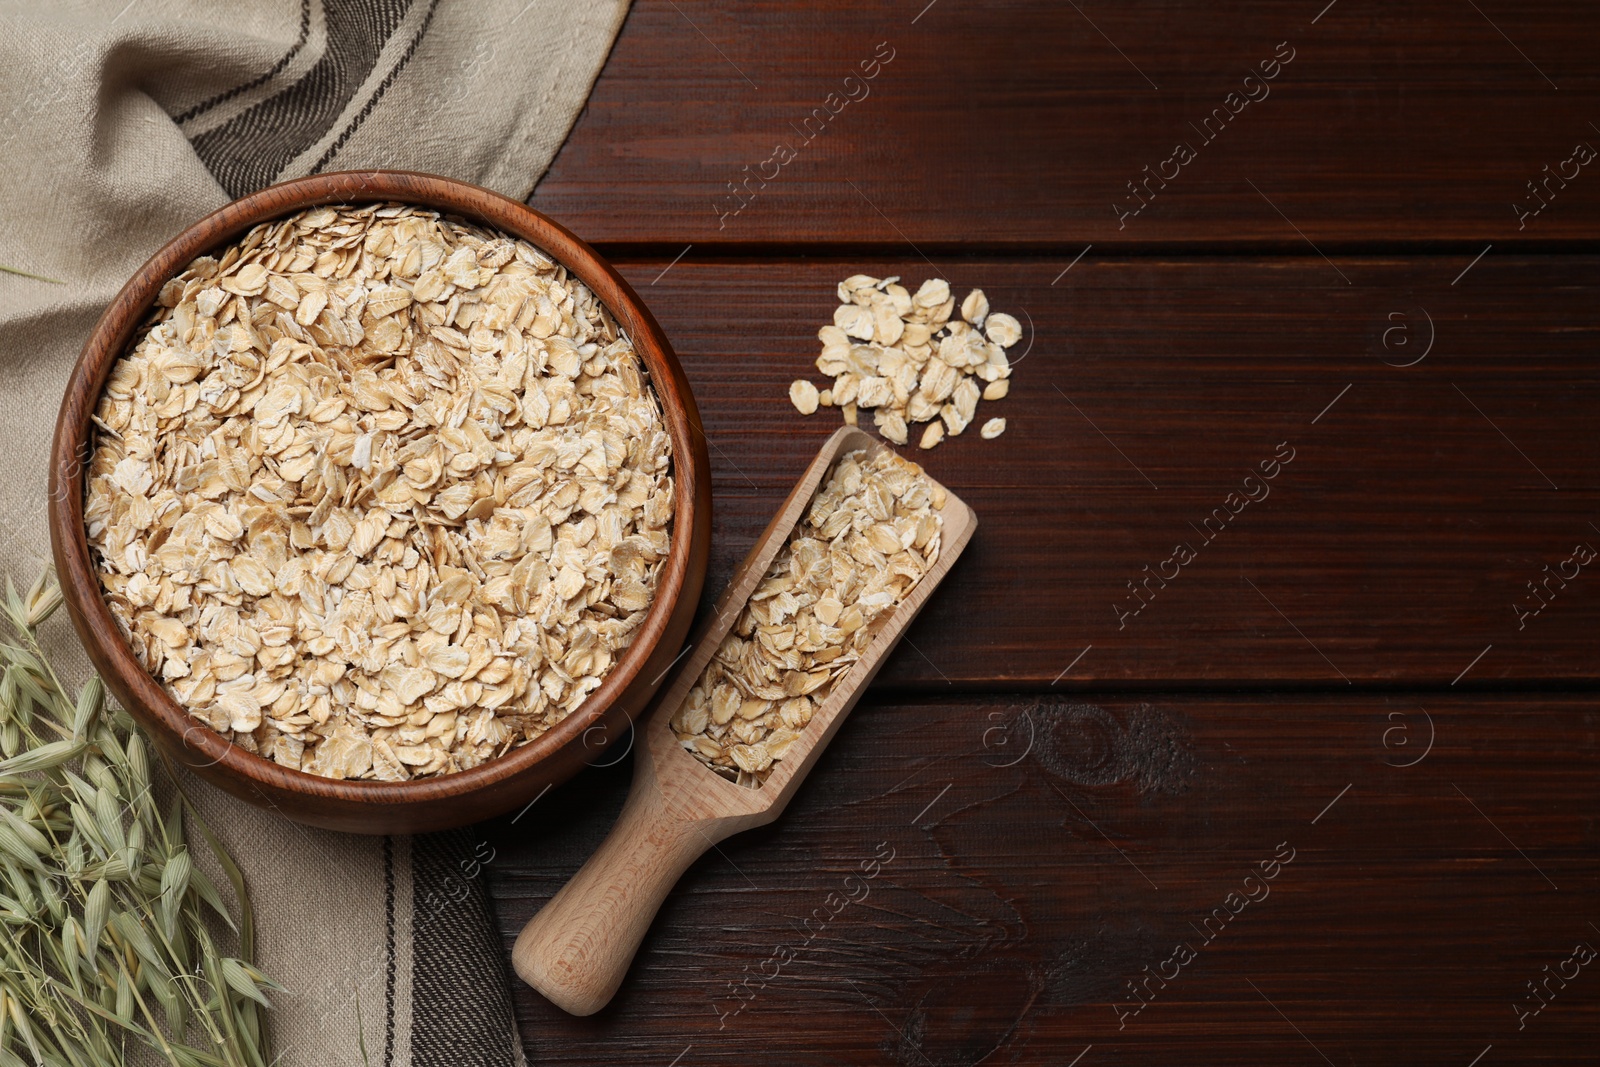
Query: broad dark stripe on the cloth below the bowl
xmin=411 ymin=830 xmax=517 ymax=1067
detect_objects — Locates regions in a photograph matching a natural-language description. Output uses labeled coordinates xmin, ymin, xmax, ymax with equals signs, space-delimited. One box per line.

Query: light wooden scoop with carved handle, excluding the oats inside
xmin=512 ymin=426 xmax=978 ymax=1016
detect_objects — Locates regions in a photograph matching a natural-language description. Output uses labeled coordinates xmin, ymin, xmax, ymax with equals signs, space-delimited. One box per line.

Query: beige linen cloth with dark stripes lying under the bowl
xmin=0 ymin=0 xmax=629 ymax=1067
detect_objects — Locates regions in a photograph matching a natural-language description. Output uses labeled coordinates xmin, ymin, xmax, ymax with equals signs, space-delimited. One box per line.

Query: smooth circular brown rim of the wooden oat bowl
xmin=50 ymin=170 xmax=709 ymax=809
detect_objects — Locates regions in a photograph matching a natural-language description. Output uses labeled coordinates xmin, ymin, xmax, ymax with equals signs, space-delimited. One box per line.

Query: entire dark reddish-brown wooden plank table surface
xmin=485 ymin=0 xmax=1600 ymax=1067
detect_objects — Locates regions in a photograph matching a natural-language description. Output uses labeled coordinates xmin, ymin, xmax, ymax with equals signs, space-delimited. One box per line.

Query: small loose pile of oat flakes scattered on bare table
xmin=789 ymin=274 xmax=1022 ymax=448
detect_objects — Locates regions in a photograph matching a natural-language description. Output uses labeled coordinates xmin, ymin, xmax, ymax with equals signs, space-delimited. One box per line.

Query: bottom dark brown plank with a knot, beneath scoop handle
xmin=483 ymin=694 xmax=1600 ymax=1067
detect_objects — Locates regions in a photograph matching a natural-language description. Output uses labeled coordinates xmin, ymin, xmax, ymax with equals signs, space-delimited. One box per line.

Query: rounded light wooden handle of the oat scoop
xmin=512 ymin=773 xmax=738 ymax=1016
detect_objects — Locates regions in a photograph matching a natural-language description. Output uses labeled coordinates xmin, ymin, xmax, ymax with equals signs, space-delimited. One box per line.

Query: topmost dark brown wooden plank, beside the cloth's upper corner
xmin=533 ymin=0 xmax=1600 ymax=246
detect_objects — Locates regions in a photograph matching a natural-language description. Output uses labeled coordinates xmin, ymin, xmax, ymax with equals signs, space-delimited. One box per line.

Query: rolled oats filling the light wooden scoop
xmin=672 ymin=447 xmax=944 ymax=787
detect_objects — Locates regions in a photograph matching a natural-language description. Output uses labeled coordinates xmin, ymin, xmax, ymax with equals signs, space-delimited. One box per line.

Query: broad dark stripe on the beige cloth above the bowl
xmin=190 ymin=0 xmax=413 ymax=197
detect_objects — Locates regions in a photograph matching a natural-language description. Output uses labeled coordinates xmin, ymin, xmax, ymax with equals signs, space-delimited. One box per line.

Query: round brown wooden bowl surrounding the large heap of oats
xmin=50 ymin=171 xmax=710 ymax=833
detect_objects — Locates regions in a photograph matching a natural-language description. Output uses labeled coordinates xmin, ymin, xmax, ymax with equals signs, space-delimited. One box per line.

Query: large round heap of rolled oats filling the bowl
xmin=85 ymin=205 xmax=674 ymax=781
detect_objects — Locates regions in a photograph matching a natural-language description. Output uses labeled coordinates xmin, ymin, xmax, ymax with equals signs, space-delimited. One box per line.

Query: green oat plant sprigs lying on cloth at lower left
xmin=0 ymin=571 xmax=280 ymax=1067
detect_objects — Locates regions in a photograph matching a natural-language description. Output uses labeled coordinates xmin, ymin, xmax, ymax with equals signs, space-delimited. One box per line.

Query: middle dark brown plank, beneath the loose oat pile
xmin=608 ymin=254 xmax=1600 ymax=688
